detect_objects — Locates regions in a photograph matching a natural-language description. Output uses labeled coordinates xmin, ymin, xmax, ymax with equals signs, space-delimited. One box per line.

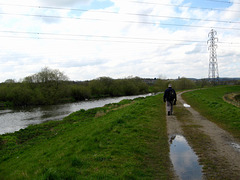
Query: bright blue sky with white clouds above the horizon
xmin=0 ymin=0 xmax=240 ymax=82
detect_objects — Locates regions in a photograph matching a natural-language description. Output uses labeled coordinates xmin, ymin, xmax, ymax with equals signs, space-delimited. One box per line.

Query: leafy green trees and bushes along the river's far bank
xmin=0 ymin=67 xmax=149 ymax=106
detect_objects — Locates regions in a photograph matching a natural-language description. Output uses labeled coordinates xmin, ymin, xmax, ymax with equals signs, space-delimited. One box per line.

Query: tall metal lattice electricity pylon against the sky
xmin=207 ymin=29 xmax=219 ymax=80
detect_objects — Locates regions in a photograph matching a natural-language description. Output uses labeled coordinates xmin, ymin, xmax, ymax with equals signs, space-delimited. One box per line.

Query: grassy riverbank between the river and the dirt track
xmin=0 ymin=95 xmax=172 ymax=179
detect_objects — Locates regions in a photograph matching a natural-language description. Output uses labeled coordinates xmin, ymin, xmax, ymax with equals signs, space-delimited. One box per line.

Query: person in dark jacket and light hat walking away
xmin=163 ymin=84 xmax=177 ymax=116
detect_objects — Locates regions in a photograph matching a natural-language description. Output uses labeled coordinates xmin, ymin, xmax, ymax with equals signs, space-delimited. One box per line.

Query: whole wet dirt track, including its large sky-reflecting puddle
xmin=167 ymin=90 xmax=240 ymax=179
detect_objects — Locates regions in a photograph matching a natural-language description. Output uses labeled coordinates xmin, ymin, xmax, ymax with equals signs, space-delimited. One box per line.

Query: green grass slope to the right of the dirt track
xmin=183 ymin=86 xmax=240 ymax=138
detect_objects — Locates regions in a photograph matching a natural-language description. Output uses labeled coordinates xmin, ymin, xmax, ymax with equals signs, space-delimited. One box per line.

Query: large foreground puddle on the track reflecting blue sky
xmin=170 ymin=135 xmax=202 ymax=180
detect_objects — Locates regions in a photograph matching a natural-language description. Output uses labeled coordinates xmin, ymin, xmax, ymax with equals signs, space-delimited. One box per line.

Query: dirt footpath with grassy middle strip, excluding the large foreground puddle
xmin=167 ymin=90 xmax=240 ymax=179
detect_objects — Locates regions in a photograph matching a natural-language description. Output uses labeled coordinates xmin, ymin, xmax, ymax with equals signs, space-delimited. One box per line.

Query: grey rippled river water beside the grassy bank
xmin=0 ymin=94 xmax=151 ymax=134
